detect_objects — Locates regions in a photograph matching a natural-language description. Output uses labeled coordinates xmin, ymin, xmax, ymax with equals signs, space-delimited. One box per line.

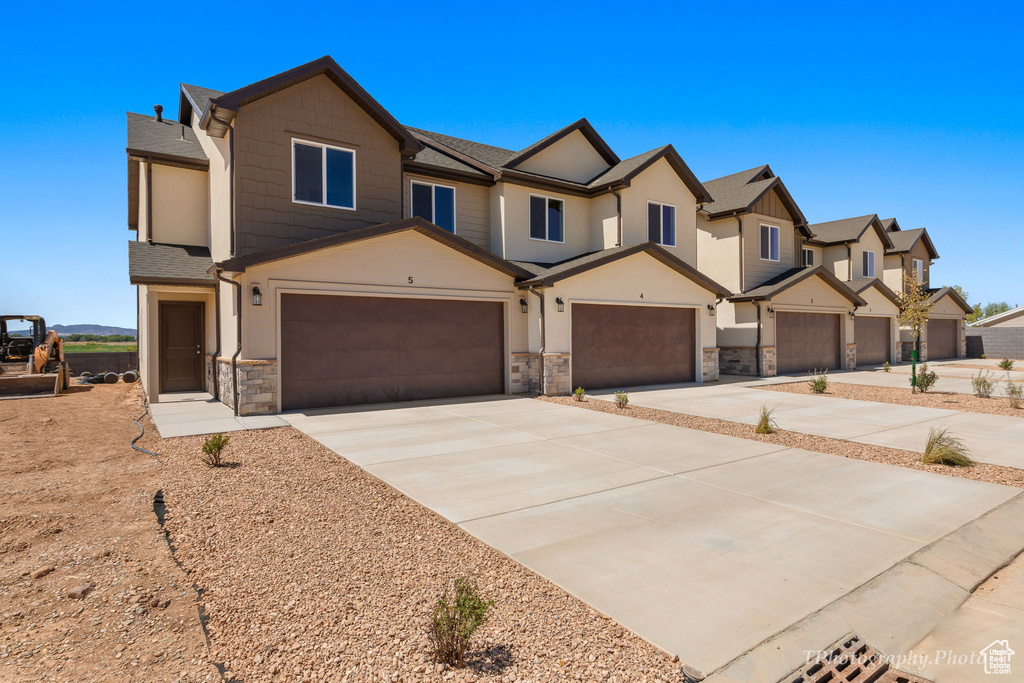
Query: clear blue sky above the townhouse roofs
xmin=0 ymin=1 xmax=1024 ymax=327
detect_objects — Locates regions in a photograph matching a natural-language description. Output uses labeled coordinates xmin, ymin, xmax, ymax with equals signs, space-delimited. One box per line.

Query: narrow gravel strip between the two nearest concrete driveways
xmin=538 ymin=397 xmax=1024 ymax=488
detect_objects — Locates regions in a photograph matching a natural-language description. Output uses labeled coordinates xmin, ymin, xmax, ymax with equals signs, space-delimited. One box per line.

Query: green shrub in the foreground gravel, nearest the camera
xmin=427 ymin=577 xmax=495 ymax=668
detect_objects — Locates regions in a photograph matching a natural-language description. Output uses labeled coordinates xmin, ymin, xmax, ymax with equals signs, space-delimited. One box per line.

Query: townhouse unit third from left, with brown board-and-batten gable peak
xmin=697 ymin=166 xmax=868 ymax=377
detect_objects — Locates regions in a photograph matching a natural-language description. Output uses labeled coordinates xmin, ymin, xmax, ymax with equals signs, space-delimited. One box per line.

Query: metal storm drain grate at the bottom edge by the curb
xmin=779 ymin=635 xmax=931 ymax=683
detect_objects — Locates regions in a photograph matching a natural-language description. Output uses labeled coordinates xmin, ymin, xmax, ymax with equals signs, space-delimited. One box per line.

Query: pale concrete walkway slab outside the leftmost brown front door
xmin=150 ymin=391 xmax=288 ymax=438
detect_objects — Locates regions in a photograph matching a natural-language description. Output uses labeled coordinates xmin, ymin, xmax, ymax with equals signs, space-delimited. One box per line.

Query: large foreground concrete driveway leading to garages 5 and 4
xmin=283 ymin=397 xmax=1024 ymax=681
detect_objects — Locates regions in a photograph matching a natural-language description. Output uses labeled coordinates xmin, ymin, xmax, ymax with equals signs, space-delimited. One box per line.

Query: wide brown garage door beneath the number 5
xmin=281 ymin=294 xmax=505 ymax=410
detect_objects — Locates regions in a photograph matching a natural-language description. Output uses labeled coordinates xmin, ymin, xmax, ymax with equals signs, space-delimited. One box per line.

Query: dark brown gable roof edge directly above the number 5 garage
xmin=217 ymin=217 xmax=532 ymax=280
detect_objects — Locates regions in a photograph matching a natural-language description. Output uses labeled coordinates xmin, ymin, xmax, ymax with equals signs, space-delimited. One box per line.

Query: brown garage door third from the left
xmin=775 ymin=312 xmax=840 ymax=375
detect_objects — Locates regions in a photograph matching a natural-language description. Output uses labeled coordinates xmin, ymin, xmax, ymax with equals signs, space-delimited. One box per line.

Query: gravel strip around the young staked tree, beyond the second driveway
xmin=753 ymin=381 xmax=1024 ymax=418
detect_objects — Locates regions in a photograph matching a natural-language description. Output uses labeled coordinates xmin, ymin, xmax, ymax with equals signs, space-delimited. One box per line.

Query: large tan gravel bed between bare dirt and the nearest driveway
xmin=157 ymin=427 xmax=685 ymax=683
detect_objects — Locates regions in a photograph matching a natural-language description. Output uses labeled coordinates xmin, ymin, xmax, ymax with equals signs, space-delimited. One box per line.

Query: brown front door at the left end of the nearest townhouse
xmin=160 ymin=301 xmax=203 ymax=393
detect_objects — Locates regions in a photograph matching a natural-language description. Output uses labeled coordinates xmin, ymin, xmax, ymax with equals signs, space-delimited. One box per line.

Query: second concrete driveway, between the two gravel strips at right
xmin=591 ymin=373 xmax=1024 ymax=469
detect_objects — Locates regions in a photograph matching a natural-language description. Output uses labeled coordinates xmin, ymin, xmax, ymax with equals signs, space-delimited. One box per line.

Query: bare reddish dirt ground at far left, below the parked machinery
xmin=0 ymin=384 xmax=220 ymax=682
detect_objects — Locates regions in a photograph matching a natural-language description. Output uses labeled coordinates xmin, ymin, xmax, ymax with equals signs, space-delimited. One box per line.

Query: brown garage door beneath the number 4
xmin=572 ymin=304 xmax=696 ymax=389
